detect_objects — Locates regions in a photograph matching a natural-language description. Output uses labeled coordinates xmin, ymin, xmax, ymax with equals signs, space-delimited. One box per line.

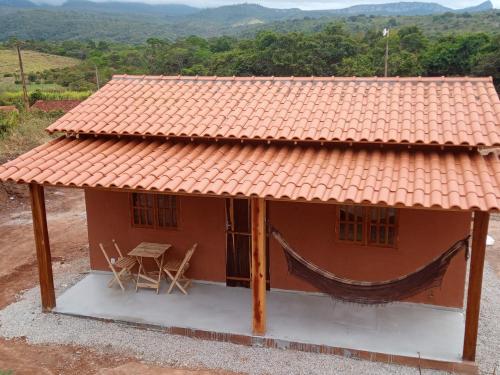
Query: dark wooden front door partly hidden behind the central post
xmin=226 ymin=198 xmax=270 ymax=289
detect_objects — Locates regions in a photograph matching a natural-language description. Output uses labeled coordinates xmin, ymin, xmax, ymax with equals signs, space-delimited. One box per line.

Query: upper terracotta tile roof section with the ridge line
xmin=48 ymin=76 xmax=500 ymax=146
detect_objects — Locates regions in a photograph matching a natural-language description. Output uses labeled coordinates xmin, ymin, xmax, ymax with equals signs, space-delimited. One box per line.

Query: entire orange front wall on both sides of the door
xmin=85 ymin=189 xmax=471 ymax=307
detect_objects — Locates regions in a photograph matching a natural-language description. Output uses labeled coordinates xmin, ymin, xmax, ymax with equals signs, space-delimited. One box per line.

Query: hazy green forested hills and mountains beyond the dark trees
xmin=0 ymin=0 xmax=500 ymax=43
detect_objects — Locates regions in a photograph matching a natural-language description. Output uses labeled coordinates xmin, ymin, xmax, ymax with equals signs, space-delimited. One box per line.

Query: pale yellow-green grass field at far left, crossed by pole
xmin=0 ymin=49 xmax=80 ymax=76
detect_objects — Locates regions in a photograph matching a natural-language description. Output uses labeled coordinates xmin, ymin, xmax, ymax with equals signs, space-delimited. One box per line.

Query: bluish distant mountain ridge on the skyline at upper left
xmin=58 ymin=0 xmax=199 ymax=16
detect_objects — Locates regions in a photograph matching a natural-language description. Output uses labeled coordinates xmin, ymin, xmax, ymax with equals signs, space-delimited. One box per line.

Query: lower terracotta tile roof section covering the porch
xmin=0 ymin=137 xmax=500 ymax=211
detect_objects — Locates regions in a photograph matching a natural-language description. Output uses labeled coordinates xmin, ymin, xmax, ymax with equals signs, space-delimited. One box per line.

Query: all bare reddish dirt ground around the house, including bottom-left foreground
xmin=0 ymin=185 xmax=500 ymax=375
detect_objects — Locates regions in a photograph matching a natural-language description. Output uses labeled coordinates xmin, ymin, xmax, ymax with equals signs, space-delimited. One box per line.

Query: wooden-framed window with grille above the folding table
xmin=131 ymin=193 xmax=178 ymax=228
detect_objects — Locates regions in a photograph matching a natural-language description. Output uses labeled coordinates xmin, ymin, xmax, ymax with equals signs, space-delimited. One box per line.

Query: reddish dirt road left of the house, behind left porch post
xmin=0 ymin=185 xmax=87 ymax=308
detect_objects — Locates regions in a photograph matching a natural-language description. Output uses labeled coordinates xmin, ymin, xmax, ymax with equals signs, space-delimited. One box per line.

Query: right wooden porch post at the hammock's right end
xmin=462 ymin=211 xmax=490 ymax=361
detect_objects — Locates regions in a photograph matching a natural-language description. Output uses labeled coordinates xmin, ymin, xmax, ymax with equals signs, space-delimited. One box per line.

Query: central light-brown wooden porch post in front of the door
xmin=251 ymin=198 xmax=266 ymax=335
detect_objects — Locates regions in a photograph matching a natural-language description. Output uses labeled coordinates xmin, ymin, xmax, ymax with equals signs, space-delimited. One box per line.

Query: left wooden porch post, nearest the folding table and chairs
xmin=29 ymin=183 xmax=56 ymax=312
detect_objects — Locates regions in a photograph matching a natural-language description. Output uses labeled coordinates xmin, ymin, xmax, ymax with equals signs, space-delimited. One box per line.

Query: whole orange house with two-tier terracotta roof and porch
xmin=0 ymin=75 xmax=500 ymax=371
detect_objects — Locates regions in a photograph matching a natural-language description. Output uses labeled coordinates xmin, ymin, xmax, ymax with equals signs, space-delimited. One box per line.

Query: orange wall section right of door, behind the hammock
xmin=268 ymin=202 xmax=471 ymax=307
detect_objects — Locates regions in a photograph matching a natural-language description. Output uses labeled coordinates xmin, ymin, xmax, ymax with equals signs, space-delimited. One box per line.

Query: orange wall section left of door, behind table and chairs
xmin=85 ymin=189 xmax=226 ymax=282
